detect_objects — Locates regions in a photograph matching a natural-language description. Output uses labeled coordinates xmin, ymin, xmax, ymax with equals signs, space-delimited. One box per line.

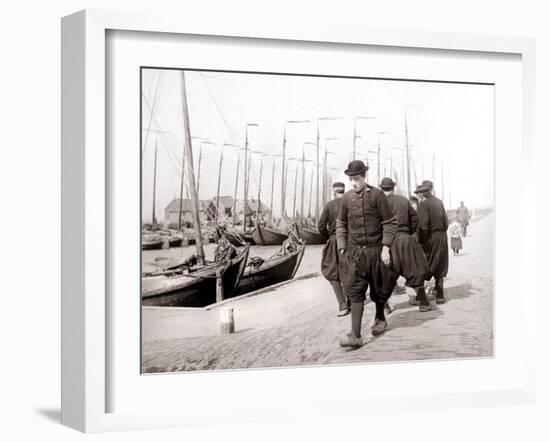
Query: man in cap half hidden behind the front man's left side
xmin=318 ymin=183 xmax=350 ymax=316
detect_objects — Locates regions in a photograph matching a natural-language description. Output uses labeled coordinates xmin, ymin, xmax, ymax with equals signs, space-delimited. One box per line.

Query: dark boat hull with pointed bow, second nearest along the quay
xmin=237 ymin=245 xmax=305 ymax=295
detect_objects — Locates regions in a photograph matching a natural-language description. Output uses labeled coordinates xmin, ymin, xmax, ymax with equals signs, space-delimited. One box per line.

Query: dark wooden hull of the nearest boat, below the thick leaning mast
xmin=141 ymin=247 xmax=249 ymax=307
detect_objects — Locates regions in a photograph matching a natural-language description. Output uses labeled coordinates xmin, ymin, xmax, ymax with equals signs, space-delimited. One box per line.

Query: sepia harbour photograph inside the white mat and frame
xmin=136 ymin=67 xmax=494 ymax=373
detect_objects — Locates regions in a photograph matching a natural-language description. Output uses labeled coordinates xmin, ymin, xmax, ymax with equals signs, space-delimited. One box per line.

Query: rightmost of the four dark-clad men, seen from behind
xmin=415 ymin=180 xmax=449 ymax=304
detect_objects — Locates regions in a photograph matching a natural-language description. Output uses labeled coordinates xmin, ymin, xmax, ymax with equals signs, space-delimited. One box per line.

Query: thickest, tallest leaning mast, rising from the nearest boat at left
xmin=181 ymin=71 xmax=205 ymax=265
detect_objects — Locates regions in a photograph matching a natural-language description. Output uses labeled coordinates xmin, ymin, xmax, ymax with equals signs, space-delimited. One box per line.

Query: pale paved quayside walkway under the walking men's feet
xmin=142 ymin=214 xmax=493 ymax=373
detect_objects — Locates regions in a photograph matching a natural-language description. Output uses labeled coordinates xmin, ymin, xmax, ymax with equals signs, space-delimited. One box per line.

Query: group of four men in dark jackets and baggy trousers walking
xmin=319 ymin=160 xmax=449 ymax=347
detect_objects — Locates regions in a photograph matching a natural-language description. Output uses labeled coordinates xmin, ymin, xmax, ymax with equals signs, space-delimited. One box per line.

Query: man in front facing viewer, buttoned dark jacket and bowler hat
xmin=336 ymin=160 xmax=397 ymax=347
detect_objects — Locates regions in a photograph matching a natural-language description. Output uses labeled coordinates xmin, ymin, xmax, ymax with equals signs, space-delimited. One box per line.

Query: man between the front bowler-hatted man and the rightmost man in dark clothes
xmin=380 ymin=178 xmax=434 ymax=312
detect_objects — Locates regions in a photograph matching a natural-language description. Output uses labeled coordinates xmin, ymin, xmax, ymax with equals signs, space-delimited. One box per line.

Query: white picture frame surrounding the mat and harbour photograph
xmin=62 ymin=10 xmax=536 ymax=432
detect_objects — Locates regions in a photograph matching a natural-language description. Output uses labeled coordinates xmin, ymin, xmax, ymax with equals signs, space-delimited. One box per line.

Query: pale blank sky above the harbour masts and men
xmin=141 ymin=69 xmax=494 ymax=222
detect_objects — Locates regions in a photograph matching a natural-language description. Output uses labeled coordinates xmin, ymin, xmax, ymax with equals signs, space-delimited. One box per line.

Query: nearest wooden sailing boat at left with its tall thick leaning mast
xmin=141 ymin=71 xmax=249 ymax=307
